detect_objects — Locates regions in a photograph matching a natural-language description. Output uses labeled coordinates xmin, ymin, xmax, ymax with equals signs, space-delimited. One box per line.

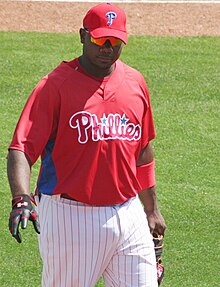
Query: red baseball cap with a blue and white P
xmin=83 ymin=3 xmax=128 ymax=44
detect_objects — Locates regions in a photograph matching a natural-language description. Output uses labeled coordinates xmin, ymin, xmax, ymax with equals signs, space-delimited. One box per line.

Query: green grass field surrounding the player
xmin=0 ymin=32 xmax=220 ymax=287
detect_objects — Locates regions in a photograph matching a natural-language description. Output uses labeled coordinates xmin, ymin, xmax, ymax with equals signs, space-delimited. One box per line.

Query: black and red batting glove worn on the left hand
xmin=8 ymin=194 xmax=40 ymax=243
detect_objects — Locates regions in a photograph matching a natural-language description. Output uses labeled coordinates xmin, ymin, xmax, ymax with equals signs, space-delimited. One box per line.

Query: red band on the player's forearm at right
xmin=137 ymin=159 xmax=156 ymax=190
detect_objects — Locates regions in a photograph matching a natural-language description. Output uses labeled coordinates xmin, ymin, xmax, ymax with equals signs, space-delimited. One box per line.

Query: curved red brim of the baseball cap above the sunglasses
xmin=89 ymin=28 xmax=128 ymax=44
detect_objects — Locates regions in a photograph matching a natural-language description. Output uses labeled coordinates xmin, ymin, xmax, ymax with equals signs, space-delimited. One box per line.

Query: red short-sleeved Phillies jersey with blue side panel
xmin=9 ymin=59 xmax=155 ymax=205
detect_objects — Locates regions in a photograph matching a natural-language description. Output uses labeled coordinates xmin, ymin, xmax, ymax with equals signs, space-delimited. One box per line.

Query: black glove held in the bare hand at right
xmin=153 ymin=233 xmax=164 ymax=286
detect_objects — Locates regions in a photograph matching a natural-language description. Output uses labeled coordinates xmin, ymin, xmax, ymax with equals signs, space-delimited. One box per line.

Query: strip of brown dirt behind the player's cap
xmin=0 ymin=0 xmax=220 ymax=36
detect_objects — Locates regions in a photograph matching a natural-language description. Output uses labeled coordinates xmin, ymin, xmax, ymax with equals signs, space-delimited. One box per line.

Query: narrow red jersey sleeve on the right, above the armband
xmin=141 ymin=76 xmax=156 ymax=148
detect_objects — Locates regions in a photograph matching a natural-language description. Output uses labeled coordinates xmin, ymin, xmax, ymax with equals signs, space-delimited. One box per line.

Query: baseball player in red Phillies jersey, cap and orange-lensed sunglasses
xmin=8 ymin=4 xmax=165 ymax=287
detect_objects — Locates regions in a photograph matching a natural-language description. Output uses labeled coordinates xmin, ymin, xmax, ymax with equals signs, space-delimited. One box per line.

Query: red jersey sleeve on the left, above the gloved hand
xmin=9 ymin=76 xmax=59 ymax=164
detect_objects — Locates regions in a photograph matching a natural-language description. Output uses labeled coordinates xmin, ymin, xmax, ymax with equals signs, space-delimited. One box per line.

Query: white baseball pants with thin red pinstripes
xmin=38 ymin=195 xmax=158 ymax=287
